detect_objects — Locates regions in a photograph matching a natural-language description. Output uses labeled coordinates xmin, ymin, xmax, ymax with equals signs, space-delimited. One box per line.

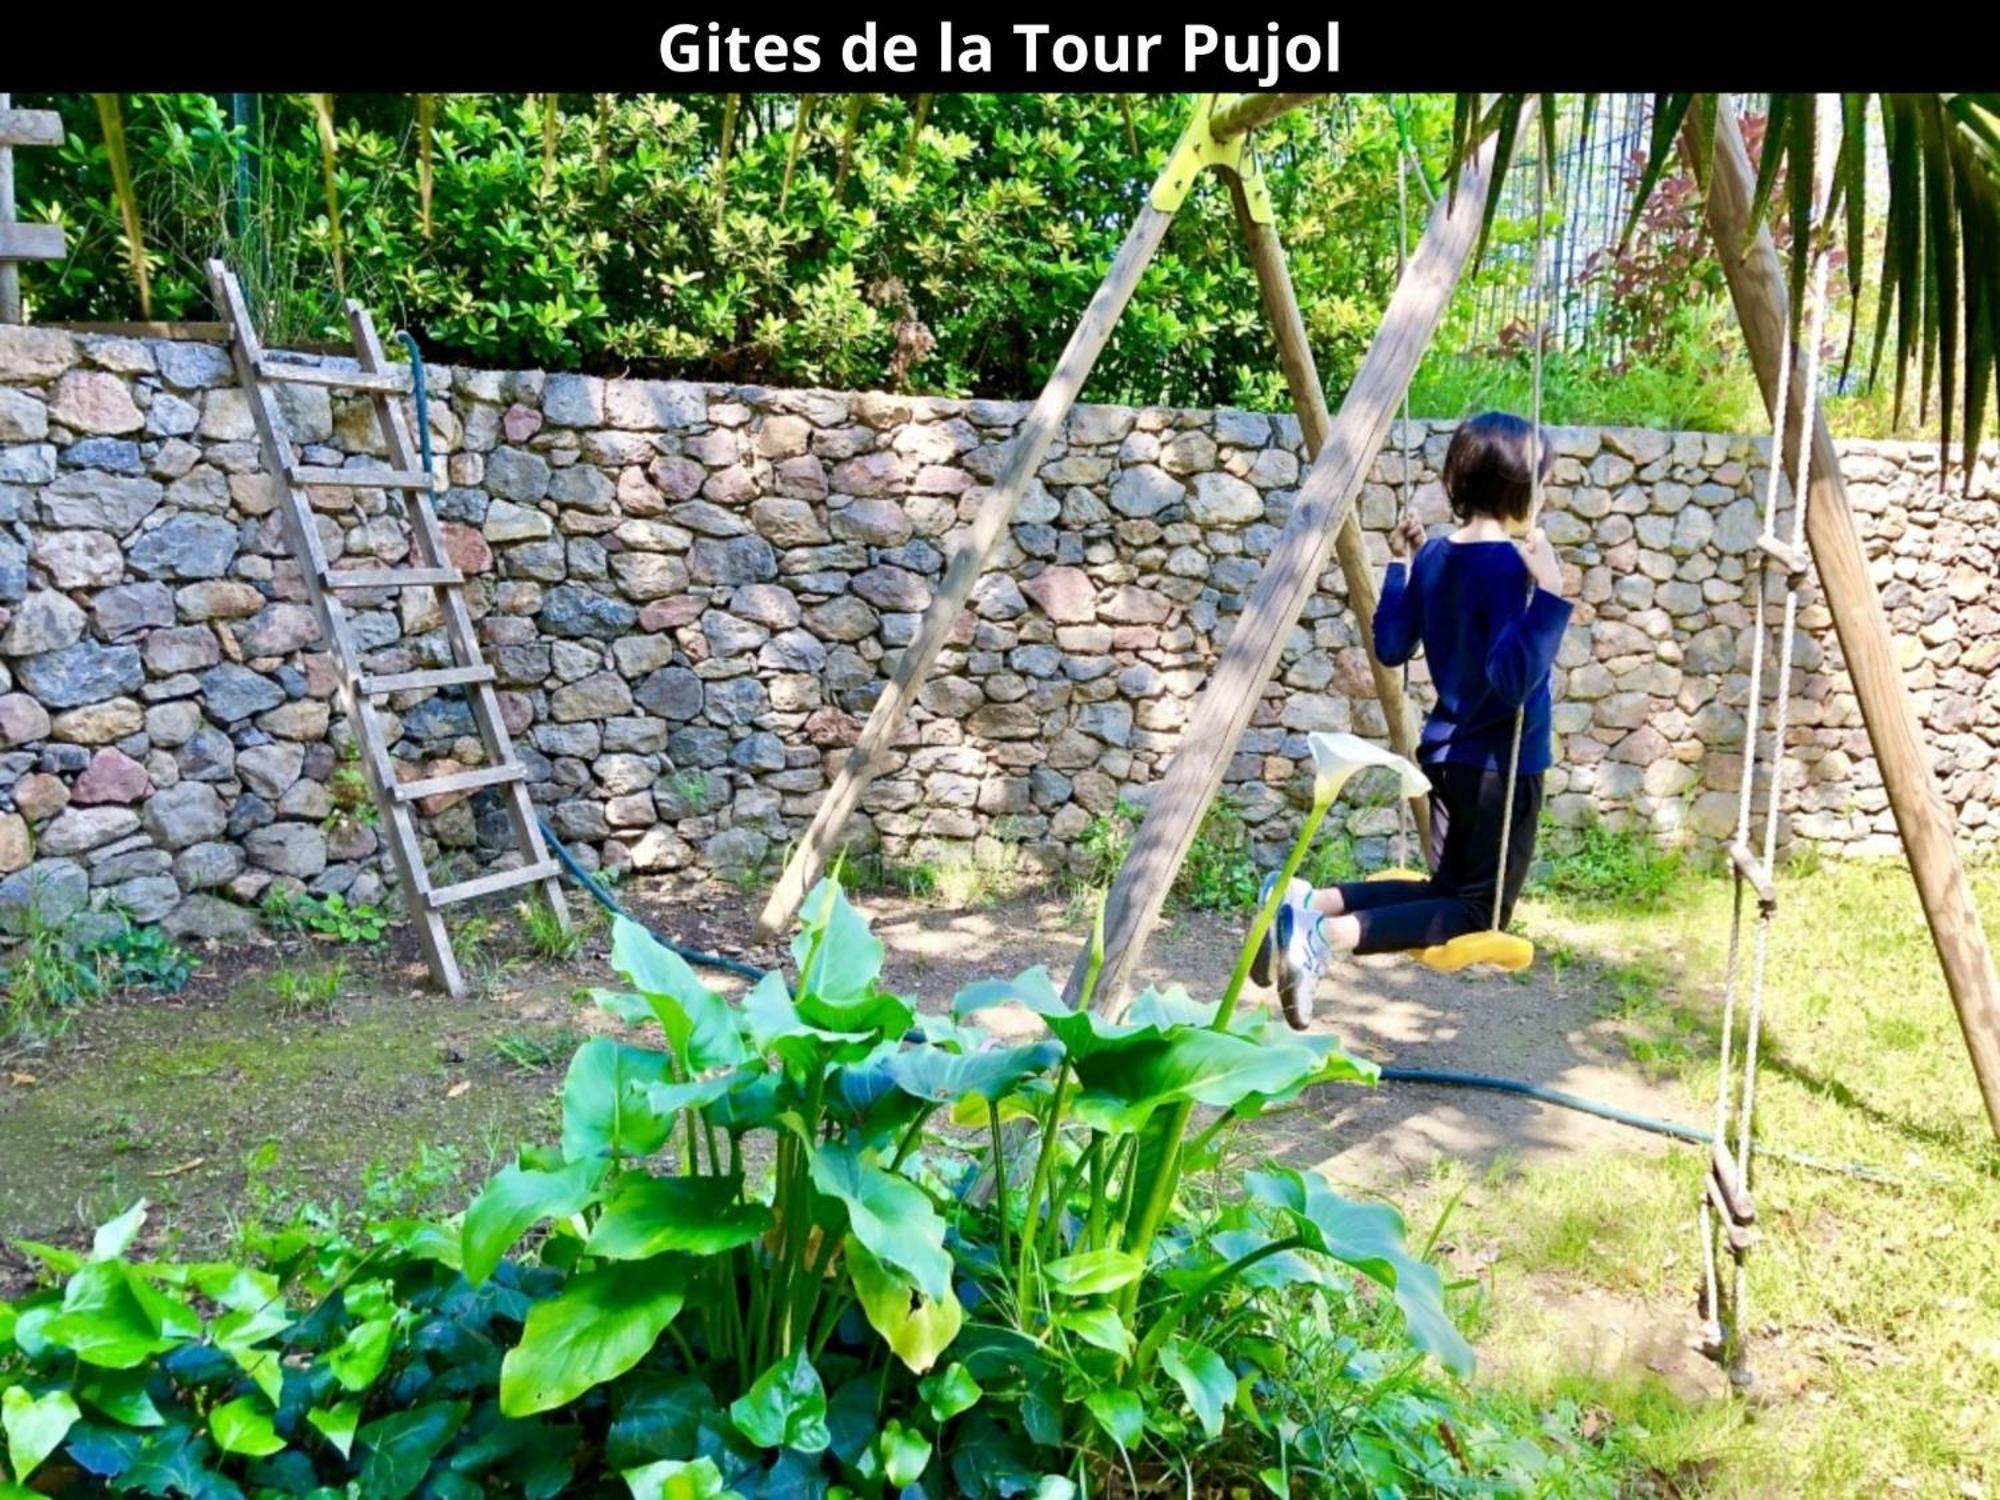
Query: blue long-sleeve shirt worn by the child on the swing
xmin=1374 ymin=536 xmax=1570 ymax=776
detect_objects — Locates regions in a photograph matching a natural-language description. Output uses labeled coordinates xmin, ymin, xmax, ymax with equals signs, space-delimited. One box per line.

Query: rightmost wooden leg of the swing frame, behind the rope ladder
xmin=1682 ymin=94 xmax=2000 ymax=1136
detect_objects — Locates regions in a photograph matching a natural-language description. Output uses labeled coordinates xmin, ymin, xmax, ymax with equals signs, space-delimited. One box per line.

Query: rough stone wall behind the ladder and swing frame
xmin=0 ymin=330 xmax=2000 ymax=932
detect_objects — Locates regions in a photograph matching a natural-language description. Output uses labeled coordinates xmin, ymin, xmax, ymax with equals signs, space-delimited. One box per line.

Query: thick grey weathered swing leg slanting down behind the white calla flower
xmin=1068 ymin=117 xmax=1494 ymax=1010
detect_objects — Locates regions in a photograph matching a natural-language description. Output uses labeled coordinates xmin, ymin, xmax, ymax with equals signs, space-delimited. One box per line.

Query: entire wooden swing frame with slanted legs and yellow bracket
xmin=758 ymin=94 xmax=2000 ymax=1136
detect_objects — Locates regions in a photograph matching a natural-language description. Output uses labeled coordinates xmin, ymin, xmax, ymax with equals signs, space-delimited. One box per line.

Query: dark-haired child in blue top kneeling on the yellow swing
xmin=1254 ymin=412 xmax=1570 ymax=1028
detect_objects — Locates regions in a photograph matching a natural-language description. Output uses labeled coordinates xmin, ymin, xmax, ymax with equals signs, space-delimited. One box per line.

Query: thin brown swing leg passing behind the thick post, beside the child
xmin=1230 ymin=176 xmax=1430 ymax=860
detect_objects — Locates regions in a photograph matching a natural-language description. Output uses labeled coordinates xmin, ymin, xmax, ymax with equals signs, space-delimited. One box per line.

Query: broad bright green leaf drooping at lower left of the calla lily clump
xmin=500 ymin=1256 xmax=686 ymax=1416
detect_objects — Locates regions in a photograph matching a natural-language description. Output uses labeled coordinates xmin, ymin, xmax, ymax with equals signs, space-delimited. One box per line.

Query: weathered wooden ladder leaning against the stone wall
xmin=208 ymin=260 xmax=570 ymax=996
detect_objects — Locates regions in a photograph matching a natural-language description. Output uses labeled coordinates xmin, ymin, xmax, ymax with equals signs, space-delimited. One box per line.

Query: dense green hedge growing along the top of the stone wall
xmin=14 ymin=92 xmax=1450 ymax=408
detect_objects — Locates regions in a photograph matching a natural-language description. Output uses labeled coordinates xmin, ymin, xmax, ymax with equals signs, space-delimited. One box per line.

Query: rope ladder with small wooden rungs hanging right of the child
xmin=1698 ymin=96 xmax=1828 ymax=1386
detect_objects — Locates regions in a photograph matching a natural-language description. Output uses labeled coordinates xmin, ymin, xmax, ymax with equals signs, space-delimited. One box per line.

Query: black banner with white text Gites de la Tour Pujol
xmin=0 ymin=11 xmax=1996 ymax=94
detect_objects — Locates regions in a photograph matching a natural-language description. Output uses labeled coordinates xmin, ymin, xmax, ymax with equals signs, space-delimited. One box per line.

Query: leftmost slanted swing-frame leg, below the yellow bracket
xmin=756 ymin=194 xmax=1174 ymax=940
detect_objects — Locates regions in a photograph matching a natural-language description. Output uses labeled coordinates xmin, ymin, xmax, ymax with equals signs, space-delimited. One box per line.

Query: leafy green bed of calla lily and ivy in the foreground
xmin=0 ymin=884 xmax=1560 ymax=1500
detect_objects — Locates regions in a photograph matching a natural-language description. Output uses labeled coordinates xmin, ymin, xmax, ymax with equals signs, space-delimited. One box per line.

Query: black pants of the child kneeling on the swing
xmin=1338 ymin=766 xmax=1542 ymax=954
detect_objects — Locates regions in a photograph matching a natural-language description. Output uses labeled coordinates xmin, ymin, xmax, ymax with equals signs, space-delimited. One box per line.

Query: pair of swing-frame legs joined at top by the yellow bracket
xmin=756 ymin=94 xmax=1422 ymax=940
